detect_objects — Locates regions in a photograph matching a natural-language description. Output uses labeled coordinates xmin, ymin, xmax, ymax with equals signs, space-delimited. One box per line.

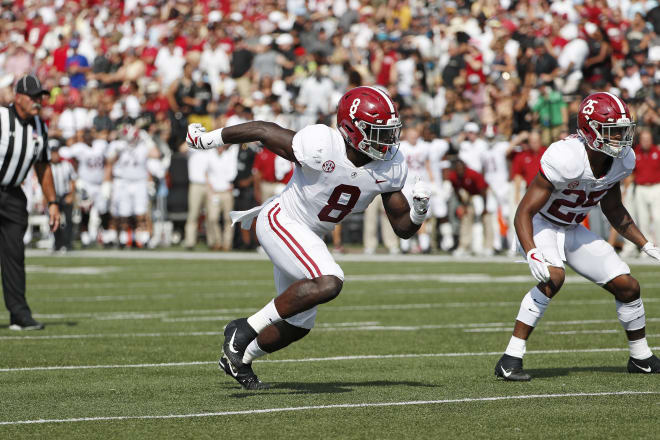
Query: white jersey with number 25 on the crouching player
xmin=540 ymin=135 xmax=635 ymax=225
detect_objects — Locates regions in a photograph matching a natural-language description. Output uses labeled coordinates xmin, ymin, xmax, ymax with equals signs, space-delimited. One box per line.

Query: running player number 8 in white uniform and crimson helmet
xmin=187 ymin=87 xmax=431 ymax=389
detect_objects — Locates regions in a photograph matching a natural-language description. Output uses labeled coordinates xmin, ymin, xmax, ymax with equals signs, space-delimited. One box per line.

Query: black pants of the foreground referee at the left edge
xmin=0 ymin=187 xmax=32 ymax=320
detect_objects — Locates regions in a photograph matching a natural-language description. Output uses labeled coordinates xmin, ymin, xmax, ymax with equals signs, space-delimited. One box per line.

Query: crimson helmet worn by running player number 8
xmin=337 ymin=87 xmax=401 ymax=160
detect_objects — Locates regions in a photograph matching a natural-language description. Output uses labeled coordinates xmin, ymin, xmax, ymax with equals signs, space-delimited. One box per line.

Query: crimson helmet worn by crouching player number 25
xmin=578 ymin=92 xmax=635 ymax=157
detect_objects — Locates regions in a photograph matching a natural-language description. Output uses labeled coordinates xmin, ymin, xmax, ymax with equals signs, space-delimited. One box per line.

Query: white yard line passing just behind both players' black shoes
xmin=0 ymin=347 xmax=660 ymax=373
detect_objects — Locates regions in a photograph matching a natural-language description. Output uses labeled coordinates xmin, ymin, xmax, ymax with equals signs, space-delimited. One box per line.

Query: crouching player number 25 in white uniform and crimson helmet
xmin=495 ymin=92 xmax=660 ymax=381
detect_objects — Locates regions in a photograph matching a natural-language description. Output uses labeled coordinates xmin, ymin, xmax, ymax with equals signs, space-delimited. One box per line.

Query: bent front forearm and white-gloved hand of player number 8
xmin=382 ymin=180 xmax=431 ymax=238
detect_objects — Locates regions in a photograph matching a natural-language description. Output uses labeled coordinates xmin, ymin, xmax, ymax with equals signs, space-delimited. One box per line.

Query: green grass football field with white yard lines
xmin=0 ymin=254 xmax=660 ymax=440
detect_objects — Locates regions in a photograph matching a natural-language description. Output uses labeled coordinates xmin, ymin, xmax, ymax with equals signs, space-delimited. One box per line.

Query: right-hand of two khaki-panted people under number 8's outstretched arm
xmin=206 ymin=145 xmax=239 ymax=251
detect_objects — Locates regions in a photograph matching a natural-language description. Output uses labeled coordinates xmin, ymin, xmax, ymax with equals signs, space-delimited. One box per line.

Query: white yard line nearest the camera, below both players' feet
xmin=0 ymin=391 xmax=660 ymax=425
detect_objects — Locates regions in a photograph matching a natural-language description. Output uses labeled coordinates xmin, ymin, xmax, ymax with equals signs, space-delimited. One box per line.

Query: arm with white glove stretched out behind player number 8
xmin=186 ymin=121 xmax=298 ymax=163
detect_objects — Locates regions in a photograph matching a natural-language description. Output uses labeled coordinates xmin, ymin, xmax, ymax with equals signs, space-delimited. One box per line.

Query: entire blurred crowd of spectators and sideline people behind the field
xmin=5 ymin=0 xmax=660 ymax=256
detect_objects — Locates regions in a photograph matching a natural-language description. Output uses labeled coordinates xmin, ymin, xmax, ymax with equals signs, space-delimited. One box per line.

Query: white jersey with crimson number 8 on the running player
xmin=280 ymin=124 xmax=408 ymax=235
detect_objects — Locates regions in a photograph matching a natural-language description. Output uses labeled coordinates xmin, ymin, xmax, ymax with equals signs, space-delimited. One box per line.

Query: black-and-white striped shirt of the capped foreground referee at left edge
xmin=0 ymin=104 xmax=50 ymax=186
